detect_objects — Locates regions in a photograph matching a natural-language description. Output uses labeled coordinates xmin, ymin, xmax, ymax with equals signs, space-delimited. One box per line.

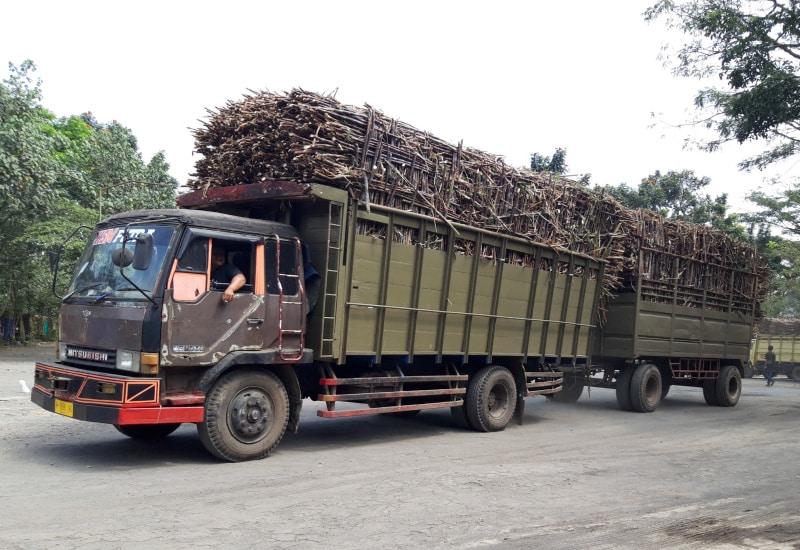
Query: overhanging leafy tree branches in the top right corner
xmin=645 ymin=0 xmax=800 ymax=169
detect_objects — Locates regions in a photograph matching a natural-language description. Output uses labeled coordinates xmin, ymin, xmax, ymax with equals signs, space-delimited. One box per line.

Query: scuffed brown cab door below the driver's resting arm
xmin=161 ymin=231 xmax=266 ymax=366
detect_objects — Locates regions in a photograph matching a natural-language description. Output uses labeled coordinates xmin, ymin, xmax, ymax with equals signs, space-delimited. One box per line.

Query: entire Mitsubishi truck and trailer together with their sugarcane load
xmin=31 ymin=90 xmax=763 ymax=461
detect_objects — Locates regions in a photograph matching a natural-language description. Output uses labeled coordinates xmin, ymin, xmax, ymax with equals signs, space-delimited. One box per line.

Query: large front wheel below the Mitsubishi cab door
xmin=197 ymin=369 xmax=289 ymax=462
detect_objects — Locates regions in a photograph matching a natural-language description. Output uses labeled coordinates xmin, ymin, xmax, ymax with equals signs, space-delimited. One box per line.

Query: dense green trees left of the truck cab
xmin=0 ymin=61 xmax=178 ymax=336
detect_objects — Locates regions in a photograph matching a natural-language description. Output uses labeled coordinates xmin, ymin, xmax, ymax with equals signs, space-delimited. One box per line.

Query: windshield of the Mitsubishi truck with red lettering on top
xmin=67 ymin=225 xmax=175 ymax=299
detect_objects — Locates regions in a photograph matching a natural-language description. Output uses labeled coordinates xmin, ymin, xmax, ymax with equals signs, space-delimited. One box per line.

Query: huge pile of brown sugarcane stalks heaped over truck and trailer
xmin=189 ymin=89 xmax=766 ymax=311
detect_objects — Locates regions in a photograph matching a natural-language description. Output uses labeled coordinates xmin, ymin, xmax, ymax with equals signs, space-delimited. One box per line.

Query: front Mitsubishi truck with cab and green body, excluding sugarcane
xmin=31 ymin=181 xmax=604 ymax=461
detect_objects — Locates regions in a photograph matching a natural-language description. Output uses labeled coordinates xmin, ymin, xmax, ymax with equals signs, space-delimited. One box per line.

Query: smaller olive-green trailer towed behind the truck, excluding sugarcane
xmin=552 ymin=245 xmax=759 ymax=412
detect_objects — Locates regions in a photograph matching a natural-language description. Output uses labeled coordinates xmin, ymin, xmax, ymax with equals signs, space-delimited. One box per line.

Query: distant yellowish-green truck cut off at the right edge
xmin=750 ymin=318 xmax=800 ymax=380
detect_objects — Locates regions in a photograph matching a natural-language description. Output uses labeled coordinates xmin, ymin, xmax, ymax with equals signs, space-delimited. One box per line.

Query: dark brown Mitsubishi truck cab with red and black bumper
xmin=32 ymin=209 xmax=309 ymax=450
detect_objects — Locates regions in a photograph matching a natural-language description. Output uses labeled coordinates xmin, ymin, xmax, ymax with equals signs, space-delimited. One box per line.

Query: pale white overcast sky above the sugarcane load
xmin=0 ymin=0 xmax=797 ymax=210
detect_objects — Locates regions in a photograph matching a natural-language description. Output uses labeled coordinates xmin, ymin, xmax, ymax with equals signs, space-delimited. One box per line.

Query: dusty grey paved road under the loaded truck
xmin=0 ymin=346 xmax=800 ymax=550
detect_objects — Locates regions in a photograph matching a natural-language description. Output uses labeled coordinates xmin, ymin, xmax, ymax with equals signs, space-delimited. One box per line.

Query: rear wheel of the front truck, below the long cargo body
xmin=465 ymin=366 xmax=517 ymax=432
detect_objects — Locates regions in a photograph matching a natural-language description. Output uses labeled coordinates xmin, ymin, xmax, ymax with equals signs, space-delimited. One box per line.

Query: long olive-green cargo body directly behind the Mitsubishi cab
xmin=293 ymin=188 xmax=602 ymax=364
